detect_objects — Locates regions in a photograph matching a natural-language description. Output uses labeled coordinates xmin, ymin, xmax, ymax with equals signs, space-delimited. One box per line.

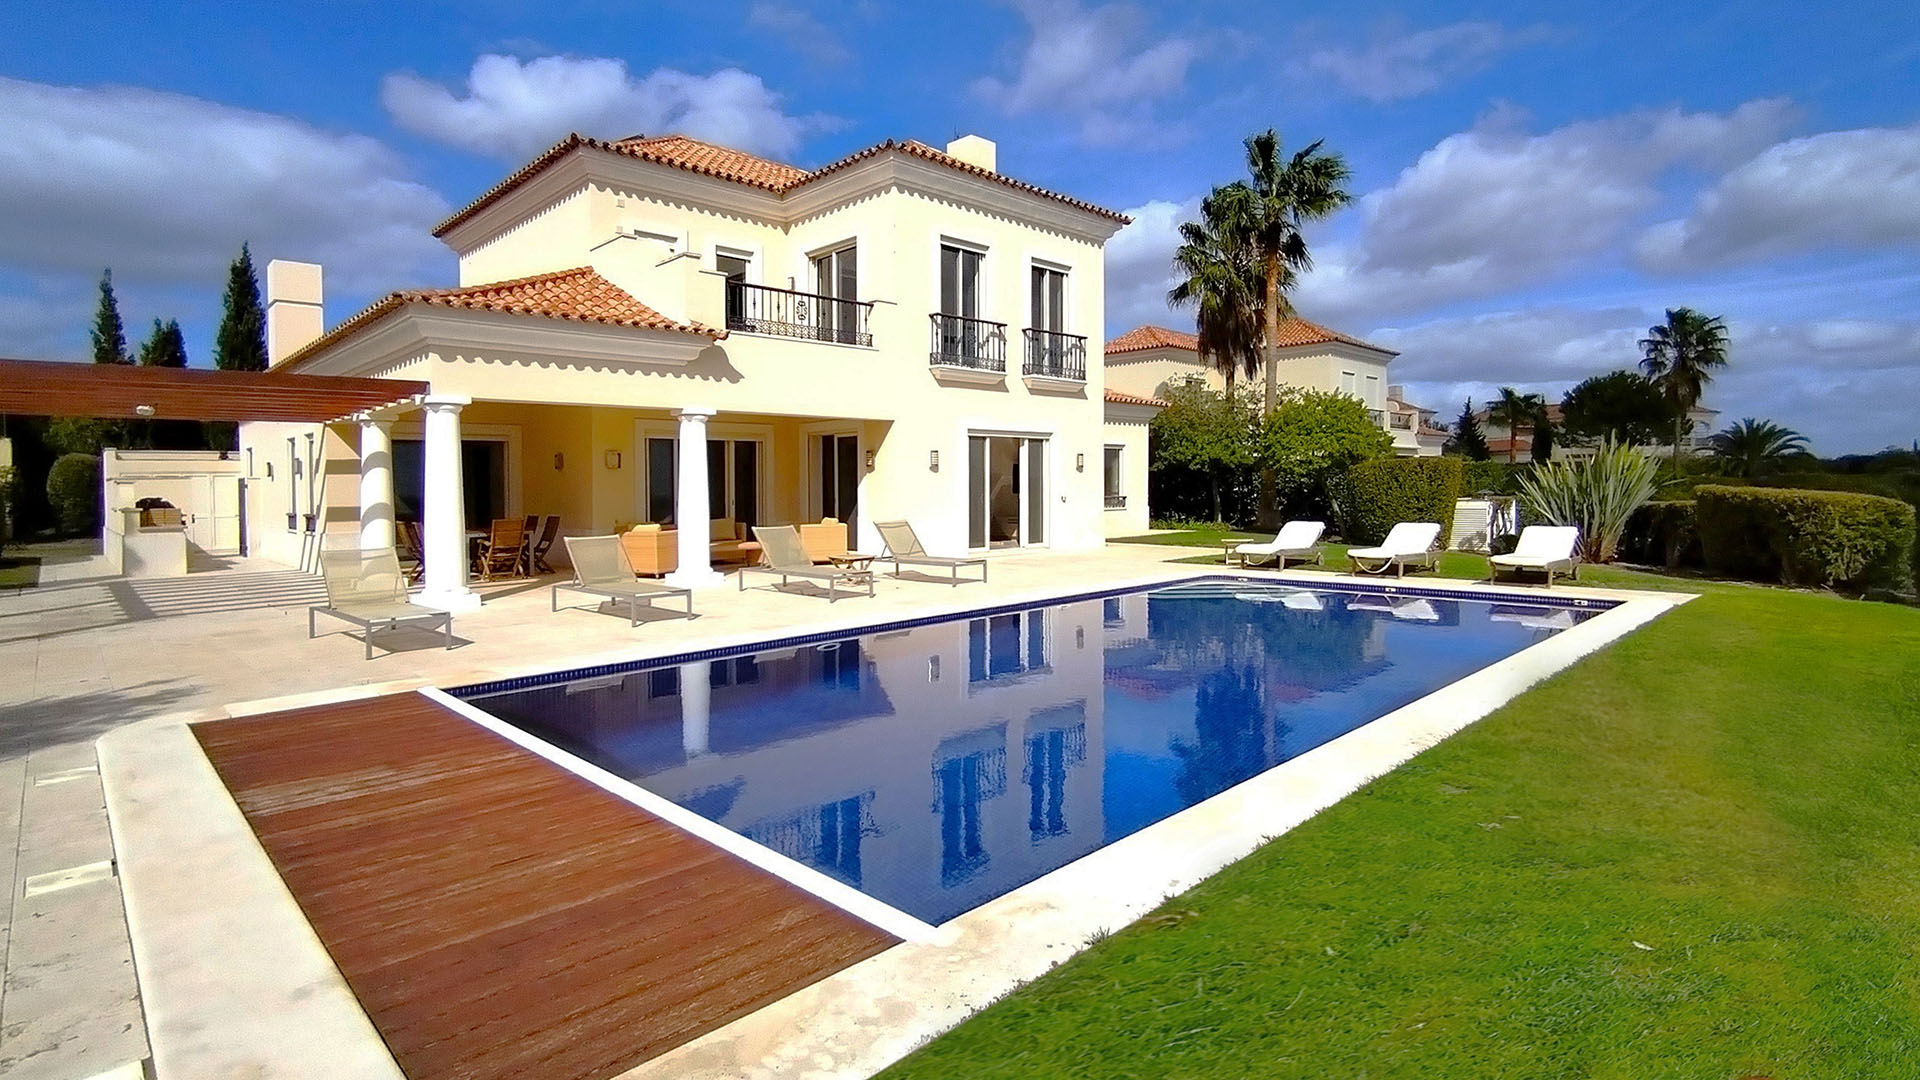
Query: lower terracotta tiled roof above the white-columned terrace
xmin=274 ymin=267 xmax=726 ymax=363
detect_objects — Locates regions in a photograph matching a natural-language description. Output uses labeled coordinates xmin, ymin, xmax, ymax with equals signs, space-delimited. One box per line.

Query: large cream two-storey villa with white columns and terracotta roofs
xmin=240 ymin=135 xmax=1152 ymax=607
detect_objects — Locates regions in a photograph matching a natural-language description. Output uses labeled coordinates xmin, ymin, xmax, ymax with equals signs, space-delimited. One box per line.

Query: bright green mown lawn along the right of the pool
xmin=883 ymin=526 xmax=1920 ymax=1080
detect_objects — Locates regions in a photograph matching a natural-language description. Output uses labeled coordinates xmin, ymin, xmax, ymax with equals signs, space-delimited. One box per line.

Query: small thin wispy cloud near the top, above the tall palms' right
xmin=1292 ymin=23 xmax=1549 ymax=104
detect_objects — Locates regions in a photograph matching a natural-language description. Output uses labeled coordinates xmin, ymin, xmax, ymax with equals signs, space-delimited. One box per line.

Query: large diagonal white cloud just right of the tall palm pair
xmin=1300 ymin=100 xmax=1791 ymax=319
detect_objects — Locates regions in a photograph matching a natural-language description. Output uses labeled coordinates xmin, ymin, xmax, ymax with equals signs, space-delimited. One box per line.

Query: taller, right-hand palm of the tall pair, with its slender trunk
xmin=1208 ymin=127 xmax=1354 ymax=525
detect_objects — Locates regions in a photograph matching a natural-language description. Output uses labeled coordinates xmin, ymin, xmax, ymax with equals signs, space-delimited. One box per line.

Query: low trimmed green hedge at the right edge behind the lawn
xmin=1693 ymin=486 xmax=1914 ymax=592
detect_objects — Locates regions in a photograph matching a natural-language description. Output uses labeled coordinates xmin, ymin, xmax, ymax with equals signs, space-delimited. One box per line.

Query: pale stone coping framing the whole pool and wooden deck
xmin=98 ymin=563 xmax=1693 ymax=1080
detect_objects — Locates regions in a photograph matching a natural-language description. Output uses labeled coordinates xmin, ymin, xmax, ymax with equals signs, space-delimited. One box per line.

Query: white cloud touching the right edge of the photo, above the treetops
xmin=1636 ymin=125 xmax=1920 ymax=271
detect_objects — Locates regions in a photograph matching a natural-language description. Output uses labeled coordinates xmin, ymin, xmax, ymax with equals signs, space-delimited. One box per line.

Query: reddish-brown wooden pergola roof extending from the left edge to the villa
xmin=0 ymin=359 xmax=428 ymax=423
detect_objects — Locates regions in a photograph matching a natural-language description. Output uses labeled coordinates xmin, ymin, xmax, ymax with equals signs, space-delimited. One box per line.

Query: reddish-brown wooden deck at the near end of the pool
xmin=194 ymin=694 xmax=893 ymax=1080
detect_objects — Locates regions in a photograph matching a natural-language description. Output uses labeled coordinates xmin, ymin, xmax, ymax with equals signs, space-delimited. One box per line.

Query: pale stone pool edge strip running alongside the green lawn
xmin=618 ymin=571 xmax=1693 ymax=1080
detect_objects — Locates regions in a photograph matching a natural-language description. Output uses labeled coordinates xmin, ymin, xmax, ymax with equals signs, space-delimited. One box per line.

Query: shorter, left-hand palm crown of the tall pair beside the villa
xmin=1167 ymin=196 xmax=1261 ymax=392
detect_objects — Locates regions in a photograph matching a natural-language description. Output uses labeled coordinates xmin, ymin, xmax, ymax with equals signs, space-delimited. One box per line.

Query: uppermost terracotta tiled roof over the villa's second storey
xmin=434 ymin=133 xmax=1129 ymax=236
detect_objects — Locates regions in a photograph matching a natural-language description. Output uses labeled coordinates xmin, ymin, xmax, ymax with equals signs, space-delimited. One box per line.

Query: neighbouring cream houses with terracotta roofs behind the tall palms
xmin=1106 ymin=317 xmax=1446 ymax=457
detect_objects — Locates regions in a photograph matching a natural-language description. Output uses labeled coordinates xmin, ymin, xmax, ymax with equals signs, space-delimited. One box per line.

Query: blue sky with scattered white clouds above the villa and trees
xmin=0 ymin=0 xmax=1920 ymax=445
